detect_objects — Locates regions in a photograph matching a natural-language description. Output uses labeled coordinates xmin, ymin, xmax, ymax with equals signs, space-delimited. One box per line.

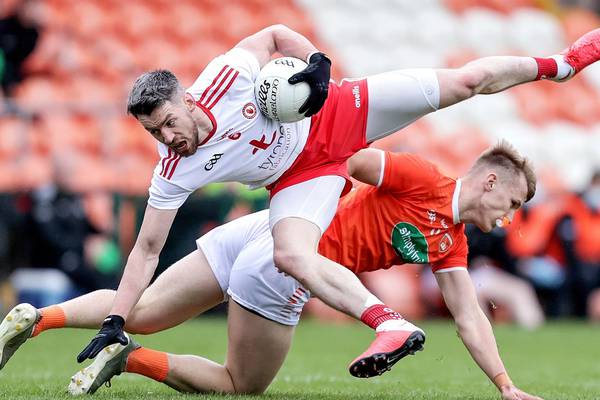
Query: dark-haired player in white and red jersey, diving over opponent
xmin=72 ymin=25 xmax=600 ymax=377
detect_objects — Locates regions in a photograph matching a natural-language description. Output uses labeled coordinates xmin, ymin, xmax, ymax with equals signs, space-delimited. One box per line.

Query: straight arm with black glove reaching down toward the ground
xmin=77 ymin=205 xmax=177 ymax=362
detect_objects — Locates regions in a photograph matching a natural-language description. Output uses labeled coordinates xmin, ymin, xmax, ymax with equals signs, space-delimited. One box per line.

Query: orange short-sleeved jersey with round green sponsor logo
xmin=319 ymin=152 xmax=468 ymax=273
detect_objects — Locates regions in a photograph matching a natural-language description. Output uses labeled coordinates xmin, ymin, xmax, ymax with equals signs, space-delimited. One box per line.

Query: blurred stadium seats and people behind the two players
xmin=0 ymin=0 xmax=600 ymax=328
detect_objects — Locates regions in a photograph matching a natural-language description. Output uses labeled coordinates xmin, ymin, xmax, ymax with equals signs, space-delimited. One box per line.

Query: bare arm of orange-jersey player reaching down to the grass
xmin=435 ymin=268 xmax=540 ymax=400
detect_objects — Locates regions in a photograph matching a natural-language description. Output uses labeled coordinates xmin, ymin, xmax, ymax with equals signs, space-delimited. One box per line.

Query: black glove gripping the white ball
xmin=288 ymin=53 xmax=331 ymax=117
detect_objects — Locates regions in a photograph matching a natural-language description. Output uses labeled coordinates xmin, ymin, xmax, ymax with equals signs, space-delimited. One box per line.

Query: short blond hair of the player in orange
xmin=471 ymin=139 xmax=537 ymax=202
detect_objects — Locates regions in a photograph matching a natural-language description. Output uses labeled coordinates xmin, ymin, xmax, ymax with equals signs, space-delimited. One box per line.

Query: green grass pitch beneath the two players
xmin=0 ymin=318 xmax=600 ymax=400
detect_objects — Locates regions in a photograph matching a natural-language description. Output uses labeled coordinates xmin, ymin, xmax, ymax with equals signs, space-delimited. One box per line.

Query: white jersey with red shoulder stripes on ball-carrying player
xmin=148 ymin=48 xmax=311 ymax=209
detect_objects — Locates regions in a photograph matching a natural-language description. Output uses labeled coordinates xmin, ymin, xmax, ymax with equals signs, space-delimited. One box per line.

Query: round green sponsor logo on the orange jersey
xmin=392 ymin=222 xmax=429 ymax=264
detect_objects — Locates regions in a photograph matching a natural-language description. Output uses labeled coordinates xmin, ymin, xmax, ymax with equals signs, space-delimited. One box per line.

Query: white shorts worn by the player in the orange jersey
xmin=196 ymin=210 xmax=310 ymax=326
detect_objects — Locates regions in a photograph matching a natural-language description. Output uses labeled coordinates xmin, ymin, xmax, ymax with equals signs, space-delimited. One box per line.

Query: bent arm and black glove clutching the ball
xmin=236 ymin=24 xmax=331 ymax=117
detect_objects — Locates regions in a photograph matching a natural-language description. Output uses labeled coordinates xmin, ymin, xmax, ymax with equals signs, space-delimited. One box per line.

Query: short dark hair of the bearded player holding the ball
xmin=127 ymin=69 xmax=183 ymax=117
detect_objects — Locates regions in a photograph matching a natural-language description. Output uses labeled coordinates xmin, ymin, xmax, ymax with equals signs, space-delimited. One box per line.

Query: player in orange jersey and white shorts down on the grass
xmin=0 ymin=143 xmax=539 ymax=400
